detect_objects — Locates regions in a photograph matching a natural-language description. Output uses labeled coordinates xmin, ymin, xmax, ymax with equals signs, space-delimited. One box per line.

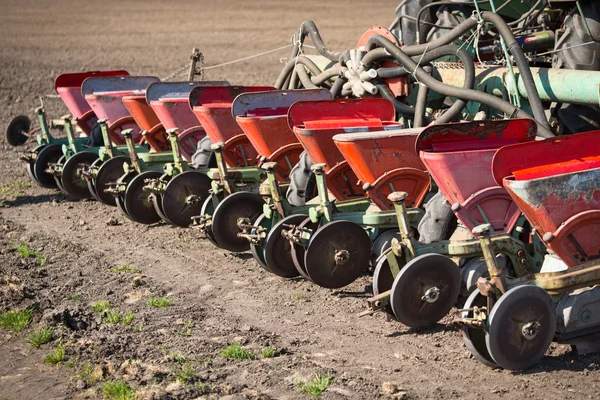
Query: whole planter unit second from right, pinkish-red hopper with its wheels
xmin=365 ymin=120 xmax=545 ymax=328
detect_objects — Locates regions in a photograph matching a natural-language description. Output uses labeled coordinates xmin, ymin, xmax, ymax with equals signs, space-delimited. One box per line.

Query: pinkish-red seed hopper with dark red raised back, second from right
xmin=416 ymin=119 xmax=537 ymax=232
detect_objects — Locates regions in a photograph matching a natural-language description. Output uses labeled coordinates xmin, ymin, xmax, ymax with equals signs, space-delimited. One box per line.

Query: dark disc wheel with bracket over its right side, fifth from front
xmin=212 ymin=192 xmax=265 ymax=253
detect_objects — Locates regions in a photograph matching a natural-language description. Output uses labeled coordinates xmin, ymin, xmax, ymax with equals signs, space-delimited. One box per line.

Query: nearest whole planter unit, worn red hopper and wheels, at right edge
xmin=456 ymin=131 xmax=600 ymax=370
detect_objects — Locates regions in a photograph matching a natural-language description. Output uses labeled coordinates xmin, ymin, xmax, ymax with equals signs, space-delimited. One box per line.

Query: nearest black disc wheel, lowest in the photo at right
xmin=485 ymin=285 xmax=556 ymax=371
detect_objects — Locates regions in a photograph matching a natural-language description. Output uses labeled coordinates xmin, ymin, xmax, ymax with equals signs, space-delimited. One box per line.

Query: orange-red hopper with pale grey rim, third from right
xmin=333 ymin=125 xmax=430 ymax=210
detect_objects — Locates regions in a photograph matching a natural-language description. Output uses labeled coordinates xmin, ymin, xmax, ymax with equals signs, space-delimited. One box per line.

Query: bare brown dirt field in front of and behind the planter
xmin=0 ymin=0 xmax=600 ymax=399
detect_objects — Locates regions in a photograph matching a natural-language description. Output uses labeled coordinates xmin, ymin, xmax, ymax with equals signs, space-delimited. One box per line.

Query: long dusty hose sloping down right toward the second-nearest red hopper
xmin=369 ymin=35 xmax=554 ymax=137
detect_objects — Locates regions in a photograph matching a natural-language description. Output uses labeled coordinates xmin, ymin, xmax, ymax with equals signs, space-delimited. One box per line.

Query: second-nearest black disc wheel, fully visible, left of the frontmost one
xmin=390 ymin=254 xmax=460 ymax=328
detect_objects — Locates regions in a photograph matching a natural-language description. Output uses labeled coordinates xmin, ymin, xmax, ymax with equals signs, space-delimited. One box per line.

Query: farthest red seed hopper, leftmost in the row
xmin=54 ymin=71 xmax=129 ymax=136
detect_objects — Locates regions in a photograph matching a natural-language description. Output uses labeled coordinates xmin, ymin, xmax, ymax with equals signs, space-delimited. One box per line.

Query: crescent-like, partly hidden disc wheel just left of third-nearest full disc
xmin=264 ymin=214 xmax=307 ymax=278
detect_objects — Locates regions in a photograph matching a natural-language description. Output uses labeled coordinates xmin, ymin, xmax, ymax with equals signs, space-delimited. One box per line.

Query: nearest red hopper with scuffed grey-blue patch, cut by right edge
xmin=492 ymin=130 xmax=600 ymax=267
